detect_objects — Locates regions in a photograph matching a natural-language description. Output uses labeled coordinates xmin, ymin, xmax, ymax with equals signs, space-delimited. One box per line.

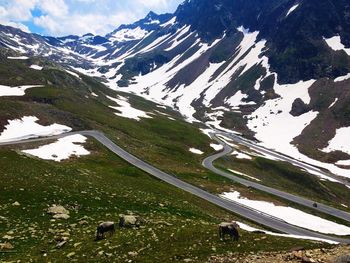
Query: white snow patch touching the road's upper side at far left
xmin=0 ymin=116 xmax=72 ymax=142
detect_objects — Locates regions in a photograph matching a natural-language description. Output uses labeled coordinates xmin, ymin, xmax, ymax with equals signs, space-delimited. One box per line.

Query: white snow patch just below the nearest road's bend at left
xmin=22 ymin=134 xmax=90 ymax=162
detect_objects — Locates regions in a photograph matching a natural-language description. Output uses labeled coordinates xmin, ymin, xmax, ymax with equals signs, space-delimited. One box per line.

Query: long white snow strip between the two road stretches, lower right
xmin=220 ymin=191 xmax=350 ymax=236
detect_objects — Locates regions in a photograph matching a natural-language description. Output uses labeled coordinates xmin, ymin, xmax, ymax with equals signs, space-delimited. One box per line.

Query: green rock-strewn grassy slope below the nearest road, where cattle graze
xmin=0 ymin=141 xmax=319 ymax=262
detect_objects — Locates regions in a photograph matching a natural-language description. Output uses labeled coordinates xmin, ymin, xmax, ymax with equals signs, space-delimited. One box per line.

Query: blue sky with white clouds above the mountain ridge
xmin=0 ymin=0 xmax=183 ymax=36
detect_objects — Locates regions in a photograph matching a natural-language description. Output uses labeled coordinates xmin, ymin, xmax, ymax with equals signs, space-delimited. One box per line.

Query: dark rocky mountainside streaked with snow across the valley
xmin=0 ymin=0 xmax=350 ymax=179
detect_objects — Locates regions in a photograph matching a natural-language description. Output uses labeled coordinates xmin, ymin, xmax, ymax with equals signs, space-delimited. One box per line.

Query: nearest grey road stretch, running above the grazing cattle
xmin=0 ymin=131 xmax=350 ymax=244
